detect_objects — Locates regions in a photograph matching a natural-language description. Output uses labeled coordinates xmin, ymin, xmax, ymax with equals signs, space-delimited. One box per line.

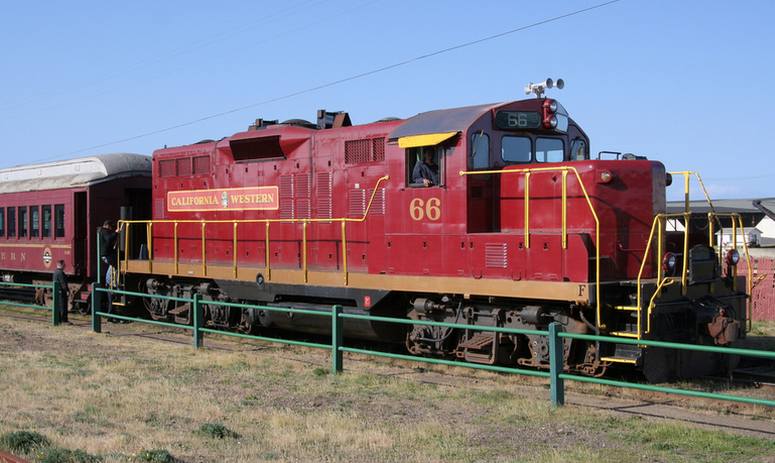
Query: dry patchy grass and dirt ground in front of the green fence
xmin=0 ymin=312 xmax=775 ymax=463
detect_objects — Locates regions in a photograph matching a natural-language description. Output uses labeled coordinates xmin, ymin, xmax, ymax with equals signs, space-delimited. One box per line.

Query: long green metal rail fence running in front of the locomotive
xmin=92 ymin=287 xmax=775 ymax=407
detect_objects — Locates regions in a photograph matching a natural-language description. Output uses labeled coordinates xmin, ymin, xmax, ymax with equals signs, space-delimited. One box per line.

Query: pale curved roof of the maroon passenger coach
xmin=0 ymin=153 xmax=151 ymax=193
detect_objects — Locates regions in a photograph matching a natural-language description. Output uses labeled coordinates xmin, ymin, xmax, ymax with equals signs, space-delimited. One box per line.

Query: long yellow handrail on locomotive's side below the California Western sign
xmin=119 ymin=175 xmax=390 ymax=284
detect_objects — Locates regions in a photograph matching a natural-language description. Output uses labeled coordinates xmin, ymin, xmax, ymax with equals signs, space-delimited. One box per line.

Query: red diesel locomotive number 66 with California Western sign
xmin=106 ymin=82 xmax=747 ymax=379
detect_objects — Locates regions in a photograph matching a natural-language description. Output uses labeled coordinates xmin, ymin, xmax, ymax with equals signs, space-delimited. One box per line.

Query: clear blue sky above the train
xmin=0 ymin=0 xmax=775 ymax=197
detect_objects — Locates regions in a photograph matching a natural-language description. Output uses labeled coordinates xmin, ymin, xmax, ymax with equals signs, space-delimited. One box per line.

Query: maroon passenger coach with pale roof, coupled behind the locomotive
xmin=0 ymin=153 xmax=151 ymax=305
